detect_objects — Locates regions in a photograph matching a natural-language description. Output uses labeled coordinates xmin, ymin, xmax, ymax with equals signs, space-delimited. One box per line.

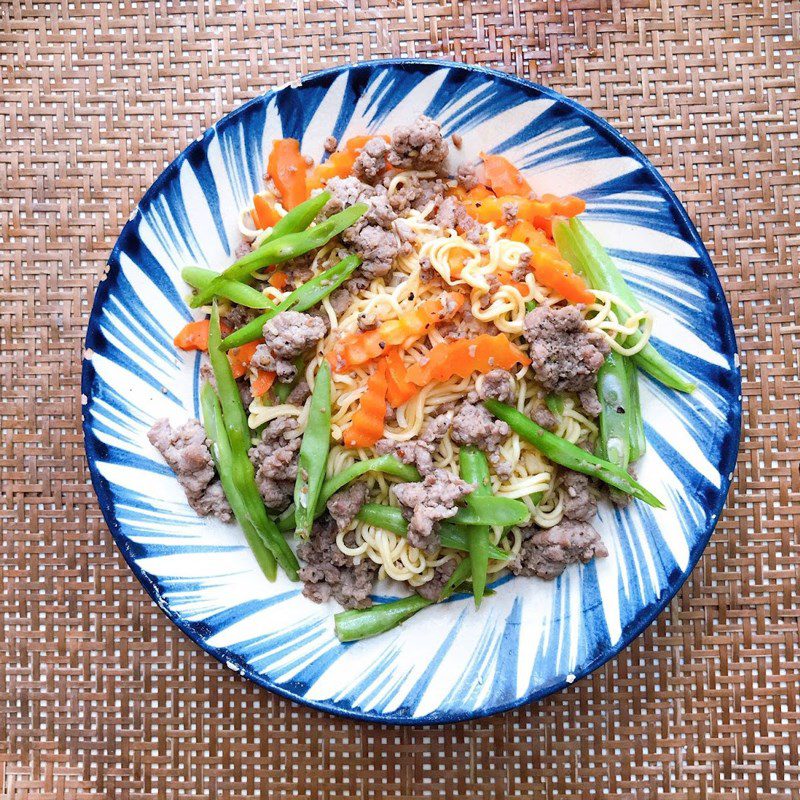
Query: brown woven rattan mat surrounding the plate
xmin=0 ymin=0 xmax=800 ymax=800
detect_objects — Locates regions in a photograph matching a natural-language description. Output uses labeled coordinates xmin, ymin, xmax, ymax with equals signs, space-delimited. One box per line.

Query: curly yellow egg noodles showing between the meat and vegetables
xmin=240 ymin=177 xmax=652 ymax=586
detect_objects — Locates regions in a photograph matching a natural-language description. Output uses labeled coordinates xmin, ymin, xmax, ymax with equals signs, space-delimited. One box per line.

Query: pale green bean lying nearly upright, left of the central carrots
xmin=294 ymin=361 xmax=331 ymax=539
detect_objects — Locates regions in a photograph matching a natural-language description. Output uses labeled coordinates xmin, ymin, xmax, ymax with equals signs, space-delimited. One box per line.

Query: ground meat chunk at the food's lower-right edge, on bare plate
xmin=509 ymin=519 xmax=608 ymax=581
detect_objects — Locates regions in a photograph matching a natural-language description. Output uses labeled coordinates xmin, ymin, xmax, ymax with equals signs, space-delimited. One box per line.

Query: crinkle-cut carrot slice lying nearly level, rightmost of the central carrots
xmin=407 ymin=333 xmax=531 ymax=386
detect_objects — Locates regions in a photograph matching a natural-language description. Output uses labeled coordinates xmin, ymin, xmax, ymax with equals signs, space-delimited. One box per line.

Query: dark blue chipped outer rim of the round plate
xmin=81 ymin=58 xmax=742 ymax=727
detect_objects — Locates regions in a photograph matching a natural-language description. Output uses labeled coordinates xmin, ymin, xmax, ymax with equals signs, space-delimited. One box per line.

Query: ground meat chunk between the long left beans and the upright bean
xmin=248 ymin=417 xmax=301 ymax=511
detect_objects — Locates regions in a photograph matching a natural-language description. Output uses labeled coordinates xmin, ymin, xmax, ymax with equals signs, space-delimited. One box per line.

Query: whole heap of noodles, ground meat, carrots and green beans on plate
xmin=150 ymin=116 xmax=693 ymax=641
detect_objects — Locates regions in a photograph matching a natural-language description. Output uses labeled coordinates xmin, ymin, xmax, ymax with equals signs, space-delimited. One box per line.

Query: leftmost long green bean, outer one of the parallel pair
xmin=200 ymin=383 xmax=277 ymax=581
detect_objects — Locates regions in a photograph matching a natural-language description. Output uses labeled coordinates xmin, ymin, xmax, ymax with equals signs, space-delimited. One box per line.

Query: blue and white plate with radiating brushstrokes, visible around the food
xmin=83 ymin=60 xmax=741 ymax=723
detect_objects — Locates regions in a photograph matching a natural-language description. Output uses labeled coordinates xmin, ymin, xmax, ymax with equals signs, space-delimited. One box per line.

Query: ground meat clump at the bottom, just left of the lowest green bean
xmin=297 ymin=514 xmax=378 ymax=608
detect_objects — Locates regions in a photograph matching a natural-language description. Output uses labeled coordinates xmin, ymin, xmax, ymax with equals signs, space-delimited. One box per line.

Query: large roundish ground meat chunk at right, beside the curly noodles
xmin=523 ymin=306 xmax=610 ymax=392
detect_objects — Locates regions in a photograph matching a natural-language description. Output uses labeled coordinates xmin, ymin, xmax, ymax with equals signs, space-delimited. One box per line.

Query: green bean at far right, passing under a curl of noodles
xmin=553 ymin=217 xmax=695 ymax=392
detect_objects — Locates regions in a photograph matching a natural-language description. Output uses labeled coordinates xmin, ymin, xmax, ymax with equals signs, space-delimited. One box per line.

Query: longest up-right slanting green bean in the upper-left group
xmin=189 ymin=203 xmax=369 ymax=308
